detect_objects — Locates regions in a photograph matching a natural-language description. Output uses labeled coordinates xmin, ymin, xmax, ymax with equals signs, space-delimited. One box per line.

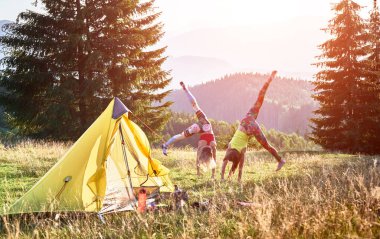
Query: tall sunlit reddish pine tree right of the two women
xmin=311 ymin=0 xmax=367 ymax=152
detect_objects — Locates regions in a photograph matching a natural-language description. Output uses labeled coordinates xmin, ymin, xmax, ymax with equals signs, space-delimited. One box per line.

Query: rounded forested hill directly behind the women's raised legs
xmin=168 ymin=73 xmax=317 ymax=134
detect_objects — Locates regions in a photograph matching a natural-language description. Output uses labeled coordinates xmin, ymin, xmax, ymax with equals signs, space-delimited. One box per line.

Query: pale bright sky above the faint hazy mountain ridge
xmin=0 ymin=0 xmax=373 ymax=33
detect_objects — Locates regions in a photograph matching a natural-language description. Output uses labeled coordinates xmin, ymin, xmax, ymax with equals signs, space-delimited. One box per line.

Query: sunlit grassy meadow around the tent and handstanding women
xmin=0 ymin=141 xmax=380 ymax=238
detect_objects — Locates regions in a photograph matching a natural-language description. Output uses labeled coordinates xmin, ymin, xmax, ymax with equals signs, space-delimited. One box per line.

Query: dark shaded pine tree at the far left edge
xmin=0 ymin=7 xmax=74 ymax=139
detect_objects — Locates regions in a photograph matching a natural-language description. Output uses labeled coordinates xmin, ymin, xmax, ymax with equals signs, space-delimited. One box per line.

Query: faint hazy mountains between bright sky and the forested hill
xmin=163 ymin=17 xmax=327 ymax=80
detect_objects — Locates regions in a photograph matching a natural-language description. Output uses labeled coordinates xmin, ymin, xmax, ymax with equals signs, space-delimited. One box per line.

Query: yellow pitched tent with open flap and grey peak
xmin=9 ymin=98 xmax=173 ymax=214
